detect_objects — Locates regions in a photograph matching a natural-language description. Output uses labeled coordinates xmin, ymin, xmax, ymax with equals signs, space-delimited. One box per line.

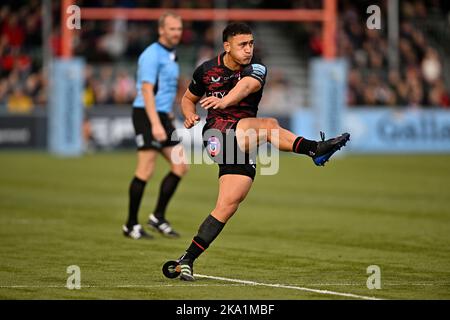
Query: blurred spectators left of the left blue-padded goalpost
xmin=0 ymin=1 xmax=47 ymax=112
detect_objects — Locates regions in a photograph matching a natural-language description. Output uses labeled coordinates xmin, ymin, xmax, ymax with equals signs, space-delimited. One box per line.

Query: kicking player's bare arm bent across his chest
xmin=200 ymin=77 xmax=261 ymax=109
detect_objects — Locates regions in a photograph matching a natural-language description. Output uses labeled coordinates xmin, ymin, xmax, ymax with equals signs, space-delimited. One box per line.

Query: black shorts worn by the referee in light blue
xmin=132 ymin=108 xmax=180 ymax=150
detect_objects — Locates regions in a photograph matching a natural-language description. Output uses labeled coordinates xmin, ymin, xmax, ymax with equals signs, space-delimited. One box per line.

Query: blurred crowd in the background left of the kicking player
xmin=0 ymin=0 xmax=219 ymax=113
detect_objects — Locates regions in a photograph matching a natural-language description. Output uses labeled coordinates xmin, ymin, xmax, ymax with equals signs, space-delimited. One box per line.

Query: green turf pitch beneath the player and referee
xmin=0 ymin=152 xmax=450 ymax=299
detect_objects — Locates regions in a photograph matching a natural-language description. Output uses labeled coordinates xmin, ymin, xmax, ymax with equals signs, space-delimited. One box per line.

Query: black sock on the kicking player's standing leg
xmin=183 ymin=215 xmax=225 ymax=262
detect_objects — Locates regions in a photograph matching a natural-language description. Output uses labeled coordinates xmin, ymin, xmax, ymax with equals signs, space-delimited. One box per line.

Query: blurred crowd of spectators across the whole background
xmin=0 ymin=0 xmax=450 ymax=113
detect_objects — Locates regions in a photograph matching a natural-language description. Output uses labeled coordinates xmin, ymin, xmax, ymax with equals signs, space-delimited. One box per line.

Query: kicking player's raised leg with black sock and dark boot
xmin=236 ymin=118 xmax=350 ymax=166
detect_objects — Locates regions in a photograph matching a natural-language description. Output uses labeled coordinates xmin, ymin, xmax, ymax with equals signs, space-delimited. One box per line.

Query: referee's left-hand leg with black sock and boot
xmin=122 ymin=149 xmax=158 ymax=239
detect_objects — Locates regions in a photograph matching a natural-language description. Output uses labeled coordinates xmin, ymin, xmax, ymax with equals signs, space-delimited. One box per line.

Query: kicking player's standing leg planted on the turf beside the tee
xmin=180 ymin=174 xmax=253 ymax=281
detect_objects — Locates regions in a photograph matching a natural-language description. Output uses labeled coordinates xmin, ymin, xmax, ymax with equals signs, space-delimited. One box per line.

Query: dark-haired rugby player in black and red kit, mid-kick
xmin=172 ymin=23 xmax=350 ymax=281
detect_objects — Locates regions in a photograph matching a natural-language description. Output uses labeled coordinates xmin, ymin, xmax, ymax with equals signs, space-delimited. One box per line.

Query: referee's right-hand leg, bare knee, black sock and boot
xmin=148 ymin=144 xmax=189 ymax=238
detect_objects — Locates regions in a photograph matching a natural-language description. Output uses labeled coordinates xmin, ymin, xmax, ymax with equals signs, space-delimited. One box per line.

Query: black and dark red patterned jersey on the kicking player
xmin=189 ymin=52 xmax=267 ymax=122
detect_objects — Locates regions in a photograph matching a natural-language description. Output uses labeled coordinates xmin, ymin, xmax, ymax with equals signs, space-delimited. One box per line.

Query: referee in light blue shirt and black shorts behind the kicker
xmin=122 ymin=12 xmax=188 ymax=239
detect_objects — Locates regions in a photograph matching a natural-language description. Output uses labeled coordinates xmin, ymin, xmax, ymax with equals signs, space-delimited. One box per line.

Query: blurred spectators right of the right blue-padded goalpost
xmin=338 ymin=1 xmax=450 ymax=108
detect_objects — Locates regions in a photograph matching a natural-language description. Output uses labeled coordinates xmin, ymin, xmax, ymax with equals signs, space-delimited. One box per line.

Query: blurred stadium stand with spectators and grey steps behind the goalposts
xmin=0 ymin=0 xmax=450 ymax=113
